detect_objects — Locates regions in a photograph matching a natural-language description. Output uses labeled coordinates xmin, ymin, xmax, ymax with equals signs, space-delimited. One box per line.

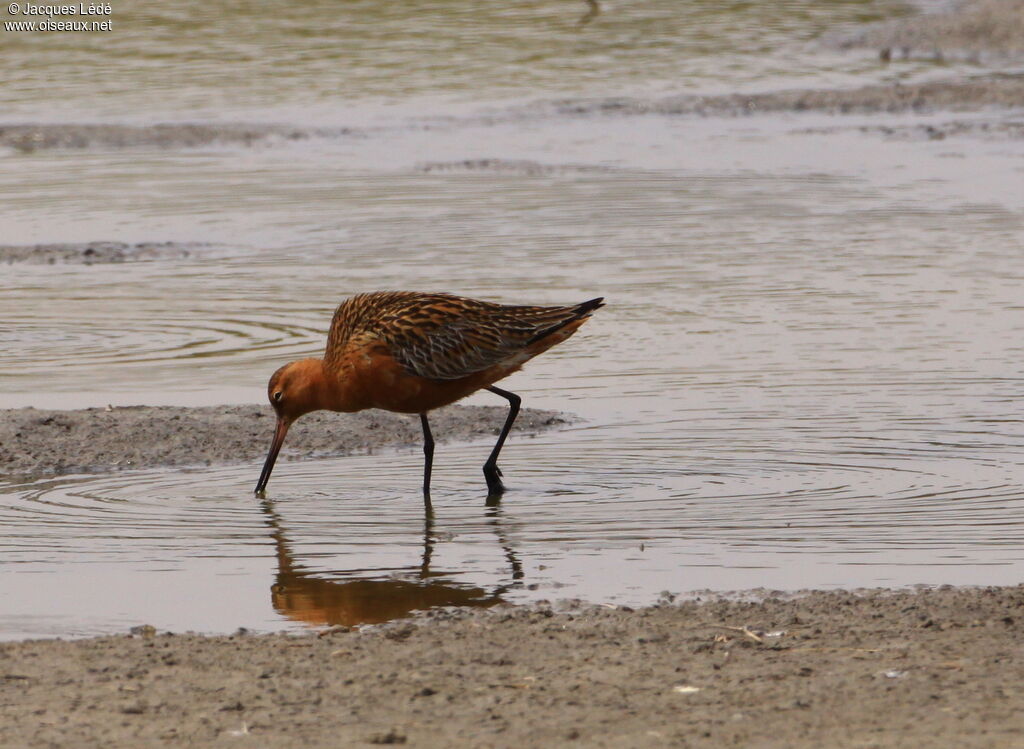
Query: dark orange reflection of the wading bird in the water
xmin=262 ymin=501 xmax=522 ymax=627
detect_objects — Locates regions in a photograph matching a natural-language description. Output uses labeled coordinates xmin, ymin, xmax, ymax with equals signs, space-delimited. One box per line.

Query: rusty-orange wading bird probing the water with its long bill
xmin=256 ymin=291 xmax=602 ymax=495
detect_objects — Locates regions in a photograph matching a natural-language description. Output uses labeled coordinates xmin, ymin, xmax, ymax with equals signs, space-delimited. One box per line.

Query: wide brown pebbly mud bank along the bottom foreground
xmin=0 ymin=587 xmax=1024 ymax=749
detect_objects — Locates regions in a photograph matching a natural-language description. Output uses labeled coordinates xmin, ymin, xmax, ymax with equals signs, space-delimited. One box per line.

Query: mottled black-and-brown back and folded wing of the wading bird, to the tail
xmin=325 ymin=291 xmax=601 ymax=380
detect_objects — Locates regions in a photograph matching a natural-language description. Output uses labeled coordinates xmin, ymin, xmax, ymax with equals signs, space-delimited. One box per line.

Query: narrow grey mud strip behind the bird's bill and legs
xmin=0 ymin=406 xmax=570 ymax=475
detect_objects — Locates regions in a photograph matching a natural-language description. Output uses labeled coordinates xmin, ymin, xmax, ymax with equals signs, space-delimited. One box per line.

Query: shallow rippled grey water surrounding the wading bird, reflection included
xmin=0 ymin=3 xmax=1024 ymax=637
